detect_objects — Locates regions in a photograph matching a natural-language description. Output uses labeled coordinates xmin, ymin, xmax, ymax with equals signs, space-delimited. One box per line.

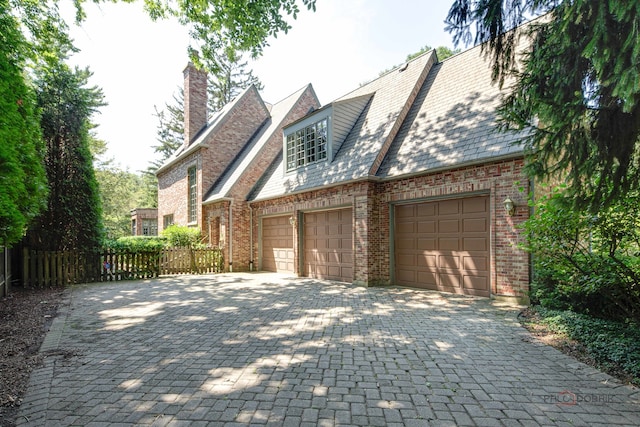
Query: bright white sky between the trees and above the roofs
xmin=63 ymin=0 xmax=456 ymax=172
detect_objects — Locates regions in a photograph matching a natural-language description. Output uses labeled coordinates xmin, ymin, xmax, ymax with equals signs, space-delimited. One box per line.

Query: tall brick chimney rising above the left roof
xmin=183 ymin=62 xmax=207 ymax=147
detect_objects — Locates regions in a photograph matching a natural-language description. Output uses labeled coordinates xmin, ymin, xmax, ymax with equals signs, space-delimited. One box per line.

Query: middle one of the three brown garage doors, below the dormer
xmin=303 ymin=209 xmax=353 ymax=282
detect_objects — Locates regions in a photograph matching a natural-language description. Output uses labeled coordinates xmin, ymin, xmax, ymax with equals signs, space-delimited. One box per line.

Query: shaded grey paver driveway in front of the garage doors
xmin=18 ymin=273 xmax=640 ymax=426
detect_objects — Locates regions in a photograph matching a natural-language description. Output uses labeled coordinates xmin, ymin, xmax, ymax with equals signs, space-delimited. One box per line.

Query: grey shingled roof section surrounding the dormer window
xmin=250 ymin=51 xmax=437 ymax=200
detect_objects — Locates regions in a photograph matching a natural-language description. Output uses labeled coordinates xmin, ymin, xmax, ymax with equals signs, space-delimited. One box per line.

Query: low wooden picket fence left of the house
xmin=22 ymin=248 xmax=222 ymax=287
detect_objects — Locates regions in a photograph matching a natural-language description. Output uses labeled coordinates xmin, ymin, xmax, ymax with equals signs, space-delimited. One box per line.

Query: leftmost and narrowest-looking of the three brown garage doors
xmin=262 ymin=215 xmax=294 ymax=273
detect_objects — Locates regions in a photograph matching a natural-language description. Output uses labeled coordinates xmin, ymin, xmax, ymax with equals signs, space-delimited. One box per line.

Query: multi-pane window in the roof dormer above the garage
xmin=287 ymin=118 xmax=328 ymax=171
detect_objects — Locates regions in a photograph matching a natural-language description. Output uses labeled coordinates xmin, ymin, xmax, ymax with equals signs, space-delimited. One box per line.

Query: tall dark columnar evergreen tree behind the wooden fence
xmin=27 ymin=56 xmax=105 ymax=250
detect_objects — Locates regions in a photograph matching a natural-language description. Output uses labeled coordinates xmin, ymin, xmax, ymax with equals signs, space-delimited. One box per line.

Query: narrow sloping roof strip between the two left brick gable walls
xmin=203 ymin=84 xmax=317 ymax=204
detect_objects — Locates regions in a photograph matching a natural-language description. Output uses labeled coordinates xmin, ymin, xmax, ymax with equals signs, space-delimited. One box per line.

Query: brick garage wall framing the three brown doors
xmin=251 ymin=159 xmax=530 ymax=297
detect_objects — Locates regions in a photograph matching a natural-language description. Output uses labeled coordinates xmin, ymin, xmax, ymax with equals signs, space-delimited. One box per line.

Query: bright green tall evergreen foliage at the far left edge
xmin=0 ymin=0 xmax=47 ymax=246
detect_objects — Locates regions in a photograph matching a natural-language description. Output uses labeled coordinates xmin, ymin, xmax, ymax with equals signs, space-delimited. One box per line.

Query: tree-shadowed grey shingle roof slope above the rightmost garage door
xmin=377 ymin=42 xmax=523 ymax=178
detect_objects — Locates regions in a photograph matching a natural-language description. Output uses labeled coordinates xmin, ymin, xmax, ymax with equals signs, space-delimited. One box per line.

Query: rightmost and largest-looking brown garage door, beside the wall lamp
xmin=394 ymin=196 xmax=491 ymax=297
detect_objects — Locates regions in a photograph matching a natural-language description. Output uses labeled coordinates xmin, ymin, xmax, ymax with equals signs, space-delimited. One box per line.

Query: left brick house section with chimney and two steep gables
xmin=156 ymin=64 xmax=320 ymax=270
